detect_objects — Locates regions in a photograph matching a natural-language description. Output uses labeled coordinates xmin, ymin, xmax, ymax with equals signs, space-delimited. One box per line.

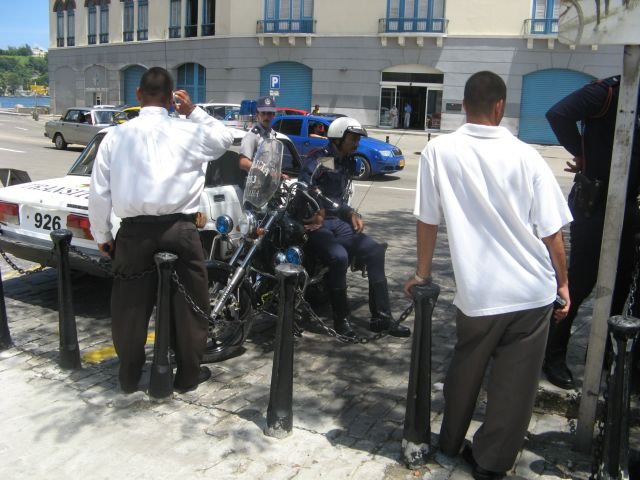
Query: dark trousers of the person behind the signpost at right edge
xmin=546 ymin=206 xmax=635 ymax=359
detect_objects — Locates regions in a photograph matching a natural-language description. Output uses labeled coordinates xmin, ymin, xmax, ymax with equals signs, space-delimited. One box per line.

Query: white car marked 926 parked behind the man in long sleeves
xmin=0 ymin=127 xmax=301 ymax=276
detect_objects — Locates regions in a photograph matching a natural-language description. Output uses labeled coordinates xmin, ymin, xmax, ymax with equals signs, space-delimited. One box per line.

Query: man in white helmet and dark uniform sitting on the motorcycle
xmin=298 ymin=117 xmax=411 ymax=337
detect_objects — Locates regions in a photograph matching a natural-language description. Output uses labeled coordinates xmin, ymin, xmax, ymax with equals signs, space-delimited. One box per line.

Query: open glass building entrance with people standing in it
xmin=378 ymin=64 xmax=444 ymax=130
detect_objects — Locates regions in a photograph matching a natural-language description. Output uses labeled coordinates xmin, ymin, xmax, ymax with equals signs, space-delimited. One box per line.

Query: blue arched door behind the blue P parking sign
xmin=260 ymin=62 xmax=312 ymax=111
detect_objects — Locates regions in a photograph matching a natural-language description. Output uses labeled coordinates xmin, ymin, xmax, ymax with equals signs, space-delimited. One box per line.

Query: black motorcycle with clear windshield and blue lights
xmin=203 ymin=140 xmax=326 ymax=362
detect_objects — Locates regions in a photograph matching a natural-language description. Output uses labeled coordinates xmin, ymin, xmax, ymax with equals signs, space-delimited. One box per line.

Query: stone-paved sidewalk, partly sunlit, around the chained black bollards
xmin=0 ymin=136 xmax=624 ymax=480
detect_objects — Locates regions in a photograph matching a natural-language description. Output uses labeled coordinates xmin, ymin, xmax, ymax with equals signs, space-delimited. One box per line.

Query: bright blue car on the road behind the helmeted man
xmin=272 ymin=115 xmax=404 ymax=180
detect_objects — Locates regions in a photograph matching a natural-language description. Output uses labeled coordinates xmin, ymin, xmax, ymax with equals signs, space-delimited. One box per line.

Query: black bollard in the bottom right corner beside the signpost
xmin=597 ymin=315 xmax=640 ymax=479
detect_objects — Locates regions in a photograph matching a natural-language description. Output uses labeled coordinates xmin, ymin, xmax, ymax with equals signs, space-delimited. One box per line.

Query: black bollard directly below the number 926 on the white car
xmin=50 ymin=229 xmax=82 ymax=368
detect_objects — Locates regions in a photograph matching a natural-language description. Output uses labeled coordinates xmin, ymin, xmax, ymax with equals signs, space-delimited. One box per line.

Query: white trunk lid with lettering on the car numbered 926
xmin=0 ymin=175 xmax=90 ymax=210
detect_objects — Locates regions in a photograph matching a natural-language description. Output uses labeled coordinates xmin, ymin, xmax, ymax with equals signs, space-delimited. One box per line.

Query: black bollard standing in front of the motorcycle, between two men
xmin=264 ymin=263 xmax=303 ymax=438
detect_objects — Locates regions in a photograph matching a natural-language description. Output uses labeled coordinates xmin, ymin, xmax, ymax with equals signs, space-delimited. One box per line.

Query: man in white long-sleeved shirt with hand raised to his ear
xmin=89 ymin=67 xmax=233 ymax=393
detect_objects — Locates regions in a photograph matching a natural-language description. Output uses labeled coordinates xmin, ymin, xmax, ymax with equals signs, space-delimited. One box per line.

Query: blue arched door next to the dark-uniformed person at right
xmin=518 ymin=68 xmax=593 ymax=145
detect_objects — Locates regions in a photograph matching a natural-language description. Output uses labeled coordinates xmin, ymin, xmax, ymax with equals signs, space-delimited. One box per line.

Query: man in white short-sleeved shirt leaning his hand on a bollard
xmin=405 ymin=72 xmax=571 ymax=480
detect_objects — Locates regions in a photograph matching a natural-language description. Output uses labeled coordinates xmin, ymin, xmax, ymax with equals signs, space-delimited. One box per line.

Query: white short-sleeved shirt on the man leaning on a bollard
xmin=414 ymin=123 xmax=572 ymax=316
